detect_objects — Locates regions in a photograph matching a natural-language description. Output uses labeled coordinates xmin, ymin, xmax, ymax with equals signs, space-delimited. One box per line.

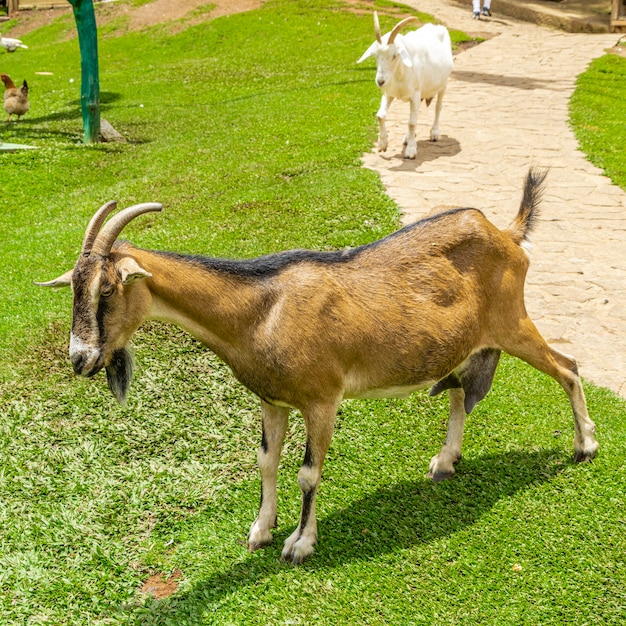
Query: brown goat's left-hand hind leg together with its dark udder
xmin=428 ymin=348 xmax=500 ymax=482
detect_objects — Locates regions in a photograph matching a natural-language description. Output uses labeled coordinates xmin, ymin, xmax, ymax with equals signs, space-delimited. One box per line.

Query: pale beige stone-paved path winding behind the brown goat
xmin=364 ymin=0 xmax=626 ymax=397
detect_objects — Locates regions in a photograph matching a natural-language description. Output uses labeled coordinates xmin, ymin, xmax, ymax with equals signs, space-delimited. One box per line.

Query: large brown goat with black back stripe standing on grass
xmin=41 ymin=170 xmax=598 ymax=563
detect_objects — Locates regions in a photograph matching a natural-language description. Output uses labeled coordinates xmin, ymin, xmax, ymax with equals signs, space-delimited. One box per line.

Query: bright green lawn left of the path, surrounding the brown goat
xmin=0 ymin=0 xmax=626 ymax=626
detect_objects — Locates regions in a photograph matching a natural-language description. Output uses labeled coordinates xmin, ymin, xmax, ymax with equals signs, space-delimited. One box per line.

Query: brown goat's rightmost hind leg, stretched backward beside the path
xmin=503 ymin=318 xmax=598 ymax=463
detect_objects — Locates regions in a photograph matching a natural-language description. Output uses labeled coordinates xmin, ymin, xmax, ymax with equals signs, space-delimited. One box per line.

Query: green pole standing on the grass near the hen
xmin=69 ymin=0 xmax=100 ymax=143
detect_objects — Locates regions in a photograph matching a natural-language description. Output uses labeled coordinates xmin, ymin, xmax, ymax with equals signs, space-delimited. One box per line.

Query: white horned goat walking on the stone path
xmin=357 ymin=12 xmax=454 ymax=159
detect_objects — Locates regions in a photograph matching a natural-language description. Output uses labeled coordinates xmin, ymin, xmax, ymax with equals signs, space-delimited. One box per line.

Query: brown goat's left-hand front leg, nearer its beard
xmin=248 ymin=401 xmax=289 ymax=552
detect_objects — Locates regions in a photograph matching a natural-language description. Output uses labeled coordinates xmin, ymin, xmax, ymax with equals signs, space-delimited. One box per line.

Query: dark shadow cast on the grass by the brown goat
xmin=129 ymin=449 xmax=572 ymax=624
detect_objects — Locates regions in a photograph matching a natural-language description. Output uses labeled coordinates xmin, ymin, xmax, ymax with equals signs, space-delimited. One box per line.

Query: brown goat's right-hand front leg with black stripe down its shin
xmin=281 ymin=404 xmax=337 ymax=564
